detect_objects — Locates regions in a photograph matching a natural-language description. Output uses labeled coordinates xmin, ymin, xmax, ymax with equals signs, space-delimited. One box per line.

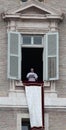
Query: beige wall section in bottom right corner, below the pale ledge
xmin=49 ymin=110 xmax=66 ymax=130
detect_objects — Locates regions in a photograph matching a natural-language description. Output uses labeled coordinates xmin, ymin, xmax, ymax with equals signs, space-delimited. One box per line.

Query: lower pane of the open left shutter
xmin=10 ymin=56 xmax=18 ymax=78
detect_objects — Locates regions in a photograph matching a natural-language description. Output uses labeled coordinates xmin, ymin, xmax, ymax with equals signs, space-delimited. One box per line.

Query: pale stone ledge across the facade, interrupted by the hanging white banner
xmin=0 ymin=90 xmax=66 ymax=110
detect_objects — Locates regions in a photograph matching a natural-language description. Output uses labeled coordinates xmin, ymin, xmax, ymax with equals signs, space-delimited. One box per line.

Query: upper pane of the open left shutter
xmin=10 ymin=33 xmax=18 ymax=54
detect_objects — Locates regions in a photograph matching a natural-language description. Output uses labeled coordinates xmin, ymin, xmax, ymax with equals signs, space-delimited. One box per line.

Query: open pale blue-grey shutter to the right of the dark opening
xmin=44 ymin=32 xmax=59 ymax=81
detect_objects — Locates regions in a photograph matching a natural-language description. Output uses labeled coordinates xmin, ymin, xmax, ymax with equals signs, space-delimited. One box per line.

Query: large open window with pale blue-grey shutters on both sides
xmin=8 ymin=32 xmax=59 ymax=81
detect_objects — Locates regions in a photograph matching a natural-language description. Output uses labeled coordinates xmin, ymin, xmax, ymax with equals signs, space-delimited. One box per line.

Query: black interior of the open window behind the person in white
xmin=21 ymin=48 xmax=43 ymax=82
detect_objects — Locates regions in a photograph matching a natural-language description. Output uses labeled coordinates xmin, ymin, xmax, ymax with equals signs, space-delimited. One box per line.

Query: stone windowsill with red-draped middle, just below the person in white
xmin=9 ymin=81 xmax=57 ymax=95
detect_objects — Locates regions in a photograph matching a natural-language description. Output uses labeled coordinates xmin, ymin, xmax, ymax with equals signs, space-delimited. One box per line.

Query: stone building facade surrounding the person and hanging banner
xmin=0 ymin=0 xmax=66 ymax=130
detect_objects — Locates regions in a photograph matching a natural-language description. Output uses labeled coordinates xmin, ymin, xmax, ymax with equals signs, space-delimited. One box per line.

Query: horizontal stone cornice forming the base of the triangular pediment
xmin=3 ymin=14 xmax=63 ymax=20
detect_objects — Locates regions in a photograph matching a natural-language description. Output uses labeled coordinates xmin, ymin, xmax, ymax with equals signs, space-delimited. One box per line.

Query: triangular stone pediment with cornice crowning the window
xmin=3 ymin=0 xmax=63 ymax=19
